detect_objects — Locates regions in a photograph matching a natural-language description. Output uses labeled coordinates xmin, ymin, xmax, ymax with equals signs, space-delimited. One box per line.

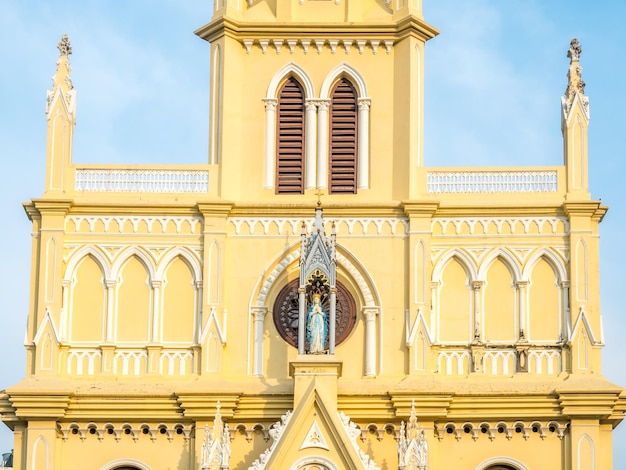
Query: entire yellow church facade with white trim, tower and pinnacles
xmin=0 ymin=0 xmax=626 ymax=470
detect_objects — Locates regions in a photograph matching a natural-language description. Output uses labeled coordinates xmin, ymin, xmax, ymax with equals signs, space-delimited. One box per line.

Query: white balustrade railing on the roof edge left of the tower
xmin=74 ymin=168 xmax=209 ymax=193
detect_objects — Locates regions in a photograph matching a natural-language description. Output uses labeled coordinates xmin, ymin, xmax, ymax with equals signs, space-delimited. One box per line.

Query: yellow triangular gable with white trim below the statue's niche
xmin=250 ymin=379 xmax=378 ymax=470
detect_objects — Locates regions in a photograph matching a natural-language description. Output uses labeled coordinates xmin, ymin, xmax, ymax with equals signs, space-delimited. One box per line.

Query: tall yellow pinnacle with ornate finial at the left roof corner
xmin=45 ymin=34 xmax=76 ymax=193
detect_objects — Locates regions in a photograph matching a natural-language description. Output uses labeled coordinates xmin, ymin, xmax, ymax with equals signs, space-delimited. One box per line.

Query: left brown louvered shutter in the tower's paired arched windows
xmin=276 ymin=78 xmax=304 ymax=194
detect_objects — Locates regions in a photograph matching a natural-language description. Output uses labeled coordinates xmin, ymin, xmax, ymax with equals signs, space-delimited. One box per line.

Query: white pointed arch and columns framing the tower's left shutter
xmin=263 ymin=62 xmax=317 ymax=189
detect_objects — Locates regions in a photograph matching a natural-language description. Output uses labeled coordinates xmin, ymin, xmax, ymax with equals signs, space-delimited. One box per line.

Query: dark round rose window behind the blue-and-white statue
xmin=273 ymin=279 xmax=356 ymax=349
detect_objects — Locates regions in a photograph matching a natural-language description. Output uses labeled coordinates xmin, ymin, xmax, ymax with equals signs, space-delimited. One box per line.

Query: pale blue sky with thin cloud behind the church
xmin=0 ymin=0 xmax=626 ymax=462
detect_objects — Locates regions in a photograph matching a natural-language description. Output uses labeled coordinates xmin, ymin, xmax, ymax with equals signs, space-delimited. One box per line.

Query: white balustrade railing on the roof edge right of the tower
xmin=426 ymin=170 xmax=558 ymax=194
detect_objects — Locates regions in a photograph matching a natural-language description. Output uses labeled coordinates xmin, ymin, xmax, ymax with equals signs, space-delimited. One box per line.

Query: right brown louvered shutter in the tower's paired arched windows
xmin=328 ymin=78 xmax=358 ymax=193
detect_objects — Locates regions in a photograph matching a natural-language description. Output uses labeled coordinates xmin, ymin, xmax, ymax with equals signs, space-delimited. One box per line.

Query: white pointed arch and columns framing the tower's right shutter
xmin=317 ymin=62 xmax=371 ymax=192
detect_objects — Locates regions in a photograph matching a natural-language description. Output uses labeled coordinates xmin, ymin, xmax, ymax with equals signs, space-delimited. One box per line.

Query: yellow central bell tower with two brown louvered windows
xmin=196 ymin=0 xmax=438 ymax=200
